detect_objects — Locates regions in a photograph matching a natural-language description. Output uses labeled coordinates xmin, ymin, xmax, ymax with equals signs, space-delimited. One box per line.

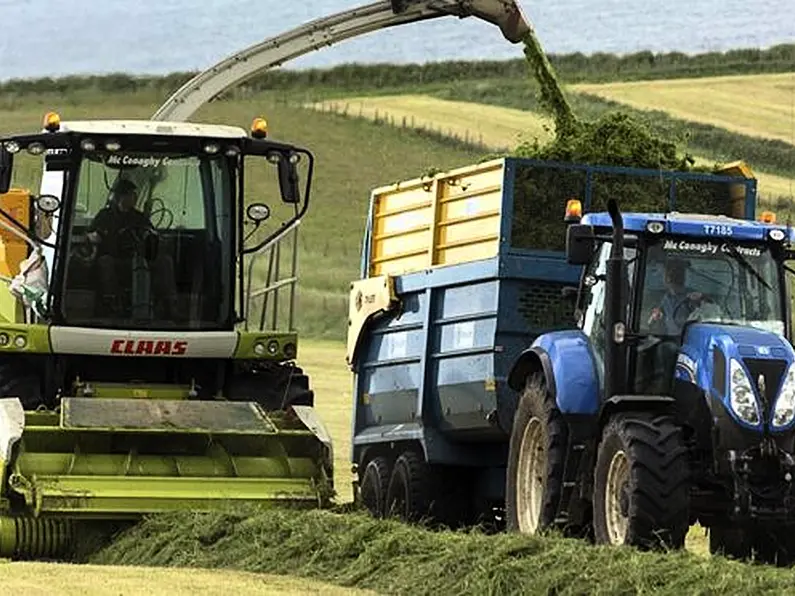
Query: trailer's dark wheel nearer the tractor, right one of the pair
xmin=386 ymin=451 xmax=432 ymax=522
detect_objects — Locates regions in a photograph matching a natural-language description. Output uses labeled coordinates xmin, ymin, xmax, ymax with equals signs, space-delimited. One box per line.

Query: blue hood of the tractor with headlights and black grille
xmin=676 ymin=323 xmax=795 ymax=432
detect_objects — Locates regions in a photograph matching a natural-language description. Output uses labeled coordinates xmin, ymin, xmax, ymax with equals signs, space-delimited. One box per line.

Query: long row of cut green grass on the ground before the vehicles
xmin=89 ymin=509 xmax=795 ymax=596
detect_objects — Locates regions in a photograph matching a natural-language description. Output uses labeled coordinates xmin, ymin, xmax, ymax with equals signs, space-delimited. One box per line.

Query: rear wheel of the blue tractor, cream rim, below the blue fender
xmin=505 ymin=376 xmax=568 ymax=534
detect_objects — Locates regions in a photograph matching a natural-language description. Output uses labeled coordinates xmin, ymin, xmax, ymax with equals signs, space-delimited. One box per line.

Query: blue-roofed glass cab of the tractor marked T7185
xmin=568 ymin=201 xmax=793 ymax=395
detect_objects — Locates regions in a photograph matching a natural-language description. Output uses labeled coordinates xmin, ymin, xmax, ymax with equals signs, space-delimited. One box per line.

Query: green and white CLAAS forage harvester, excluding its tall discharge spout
xmin=0 ymin=113 xmax=333 ymax=556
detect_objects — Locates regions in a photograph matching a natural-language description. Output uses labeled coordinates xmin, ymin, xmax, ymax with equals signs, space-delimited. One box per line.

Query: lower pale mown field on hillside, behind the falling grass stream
xmin=310 ymin=93 xmax=795 ymax=200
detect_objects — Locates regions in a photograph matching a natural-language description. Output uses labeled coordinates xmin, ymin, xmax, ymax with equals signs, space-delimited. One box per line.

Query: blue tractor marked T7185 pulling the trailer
xmin=505 ymin=200 xmax=795 ymax=565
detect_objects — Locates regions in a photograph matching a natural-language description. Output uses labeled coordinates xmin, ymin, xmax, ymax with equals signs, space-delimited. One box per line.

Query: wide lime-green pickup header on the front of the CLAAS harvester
xmin=0 ymin=397 xmax=333 ymax=519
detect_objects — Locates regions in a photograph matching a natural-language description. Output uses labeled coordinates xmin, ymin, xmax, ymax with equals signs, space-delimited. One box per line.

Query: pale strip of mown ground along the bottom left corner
xmin=0 ymin=563 xmax=373 ymax=596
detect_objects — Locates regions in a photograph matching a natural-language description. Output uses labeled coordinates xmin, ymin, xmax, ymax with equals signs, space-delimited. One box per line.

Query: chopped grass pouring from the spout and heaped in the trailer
xmin=504 ymin=30 xmax=752 ymax=250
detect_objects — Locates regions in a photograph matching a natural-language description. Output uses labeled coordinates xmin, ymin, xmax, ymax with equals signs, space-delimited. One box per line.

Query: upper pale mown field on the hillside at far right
xmin=570 ymin=72 xmax=795 ymax=144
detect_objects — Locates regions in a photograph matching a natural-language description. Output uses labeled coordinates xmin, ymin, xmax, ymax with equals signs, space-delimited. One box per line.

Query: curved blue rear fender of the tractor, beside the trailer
xmin=508 ymin=330 xmax=601 ymax=415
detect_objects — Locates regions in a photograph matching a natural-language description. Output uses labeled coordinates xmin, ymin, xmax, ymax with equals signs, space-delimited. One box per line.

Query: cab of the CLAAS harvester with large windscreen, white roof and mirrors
xmin=0 ymin=113 xmax=312 ymax=331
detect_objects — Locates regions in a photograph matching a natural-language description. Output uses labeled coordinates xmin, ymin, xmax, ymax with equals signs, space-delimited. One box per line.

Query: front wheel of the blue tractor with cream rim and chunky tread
xmin=593 ymin=413 xmax=690 ymax=549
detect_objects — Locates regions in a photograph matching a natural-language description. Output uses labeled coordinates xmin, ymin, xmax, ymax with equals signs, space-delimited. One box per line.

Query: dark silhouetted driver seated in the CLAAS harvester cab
xmin=87 ymin=179 xmax=177 ymax=318
